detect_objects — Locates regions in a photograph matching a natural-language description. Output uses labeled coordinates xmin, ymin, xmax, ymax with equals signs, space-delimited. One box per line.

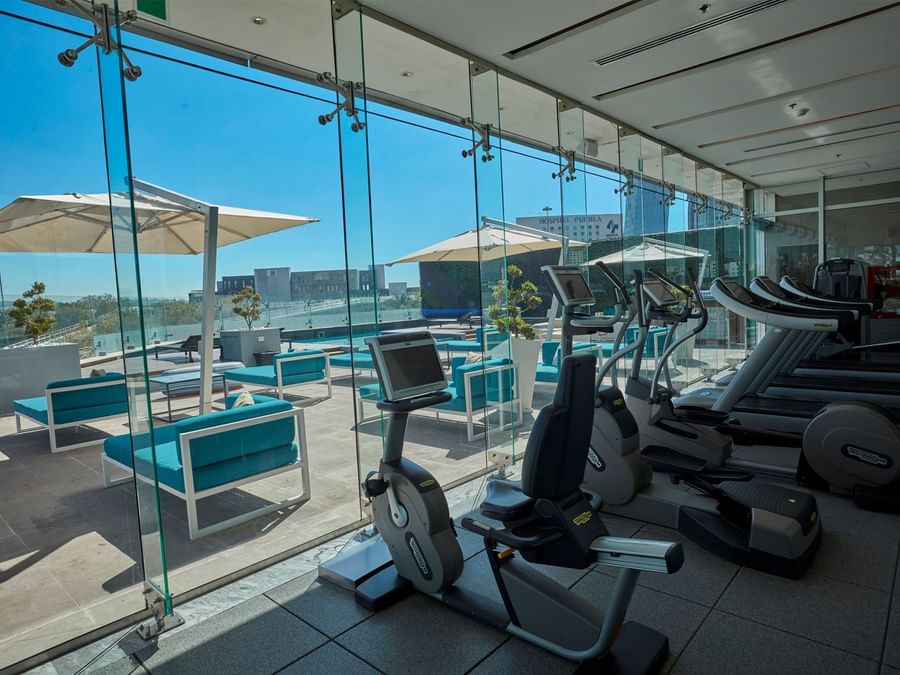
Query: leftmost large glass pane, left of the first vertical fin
xmin=0 ymin=0 xmax=149 ymax=672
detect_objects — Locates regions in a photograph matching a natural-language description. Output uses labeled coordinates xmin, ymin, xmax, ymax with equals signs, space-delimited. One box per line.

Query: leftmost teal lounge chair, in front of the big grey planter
xmin=13 ymin=373 xmax=128 ymax=452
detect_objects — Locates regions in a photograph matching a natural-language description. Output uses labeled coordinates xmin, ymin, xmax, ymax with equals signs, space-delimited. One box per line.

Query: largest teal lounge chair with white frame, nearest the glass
xmin=101 ymin=394 xmax=310 ymax=539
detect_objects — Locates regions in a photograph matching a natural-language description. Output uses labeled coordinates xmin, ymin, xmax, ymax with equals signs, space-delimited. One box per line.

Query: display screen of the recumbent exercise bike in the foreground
xmin=372 ymin=340 xmax=447 ymax=401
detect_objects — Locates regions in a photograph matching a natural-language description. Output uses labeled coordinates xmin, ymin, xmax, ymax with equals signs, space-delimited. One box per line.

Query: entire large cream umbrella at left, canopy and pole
xmin=0 ymin=178 xmax=318 ymax=413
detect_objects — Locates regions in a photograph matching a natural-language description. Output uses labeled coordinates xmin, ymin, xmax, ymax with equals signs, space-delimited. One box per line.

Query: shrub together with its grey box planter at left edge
xmin=0 ymin=281 xmax=81 ymax=414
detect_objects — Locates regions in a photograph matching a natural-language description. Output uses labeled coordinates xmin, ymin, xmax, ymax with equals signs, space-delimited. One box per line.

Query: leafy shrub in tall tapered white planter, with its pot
xmin=488 ymin=265 xmax=541 ymax=411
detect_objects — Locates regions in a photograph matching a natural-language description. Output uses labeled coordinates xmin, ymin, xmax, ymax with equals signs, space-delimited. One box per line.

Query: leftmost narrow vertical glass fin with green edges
xmin=97 ymin=3 xmax=172 ymax=614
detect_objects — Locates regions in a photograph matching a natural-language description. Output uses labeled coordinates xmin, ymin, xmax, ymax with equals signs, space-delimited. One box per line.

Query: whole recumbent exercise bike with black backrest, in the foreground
xmin=320 ymin=333 xmax=684 ymax=673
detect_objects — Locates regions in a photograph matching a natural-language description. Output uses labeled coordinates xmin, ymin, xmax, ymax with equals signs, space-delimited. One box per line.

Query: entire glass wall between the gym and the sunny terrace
xmin=0 ymin=1 xmax=743 ymax=668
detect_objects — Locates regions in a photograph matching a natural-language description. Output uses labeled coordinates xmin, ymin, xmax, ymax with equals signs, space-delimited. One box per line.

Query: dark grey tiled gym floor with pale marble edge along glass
xmin=24 ymin=490 xmax=900 ymax=675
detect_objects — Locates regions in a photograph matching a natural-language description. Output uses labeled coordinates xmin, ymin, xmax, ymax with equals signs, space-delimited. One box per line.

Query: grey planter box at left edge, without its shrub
xmin=0 ymin=342 xmax=81 ymax=415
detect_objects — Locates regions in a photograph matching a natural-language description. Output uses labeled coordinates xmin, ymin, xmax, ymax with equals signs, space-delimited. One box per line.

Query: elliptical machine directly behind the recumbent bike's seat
xmin=542 ymin=263 xmax=822 ymax=578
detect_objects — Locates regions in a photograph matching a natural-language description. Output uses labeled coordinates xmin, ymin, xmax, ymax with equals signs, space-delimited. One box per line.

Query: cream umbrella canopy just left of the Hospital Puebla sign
xmin=388 ymin=225 xmax=585 ymax=265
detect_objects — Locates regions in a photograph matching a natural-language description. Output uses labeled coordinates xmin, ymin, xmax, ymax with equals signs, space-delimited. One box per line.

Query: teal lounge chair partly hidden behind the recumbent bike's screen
xmin=357 ymin=357 xmax=522 ymax=442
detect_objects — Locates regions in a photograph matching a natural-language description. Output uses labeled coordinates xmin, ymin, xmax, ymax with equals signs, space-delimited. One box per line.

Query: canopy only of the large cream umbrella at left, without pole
xmin=0 ymin=192 xmax=317 ymax=255
